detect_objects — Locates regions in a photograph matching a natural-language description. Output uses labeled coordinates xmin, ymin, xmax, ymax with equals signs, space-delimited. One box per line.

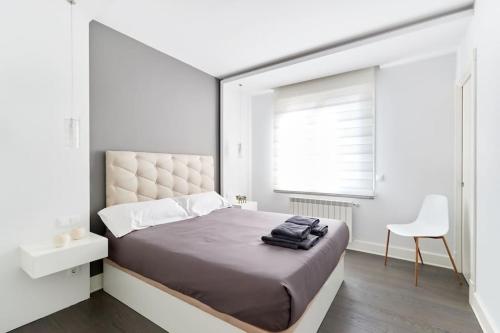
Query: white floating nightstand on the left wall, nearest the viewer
xmin=20 ymin=232 xmax=108 ymax=279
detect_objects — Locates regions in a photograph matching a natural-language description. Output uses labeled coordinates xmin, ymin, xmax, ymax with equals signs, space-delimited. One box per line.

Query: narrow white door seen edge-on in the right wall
xmin=462 ymin=77 xmax=475 ymax=284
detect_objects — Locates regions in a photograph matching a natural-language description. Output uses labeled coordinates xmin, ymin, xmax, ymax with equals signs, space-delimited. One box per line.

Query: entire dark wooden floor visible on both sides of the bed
xmin=13 ymin=252 xmax=481 ymax=333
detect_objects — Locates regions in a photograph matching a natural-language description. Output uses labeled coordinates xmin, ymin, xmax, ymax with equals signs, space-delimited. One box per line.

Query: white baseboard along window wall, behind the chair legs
xmin=347 ymin=240 xmax=452 ymax=269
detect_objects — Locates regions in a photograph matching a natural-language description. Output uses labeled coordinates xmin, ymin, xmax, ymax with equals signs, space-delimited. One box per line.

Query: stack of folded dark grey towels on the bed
xmin=262 ymin=216 xmax=328 ymax=250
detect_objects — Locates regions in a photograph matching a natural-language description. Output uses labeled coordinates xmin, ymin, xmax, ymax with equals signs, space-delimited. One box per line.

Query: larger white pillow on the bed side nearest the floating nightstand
xmin=97 ymin=198 xmax=189 ymax=237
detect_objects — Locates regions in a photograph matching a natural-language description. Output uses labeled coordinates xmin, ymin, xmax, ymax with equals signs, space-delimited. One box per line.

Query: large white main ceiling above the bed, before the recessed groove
xmin=96 ymin=0 xmax=472 ymax=77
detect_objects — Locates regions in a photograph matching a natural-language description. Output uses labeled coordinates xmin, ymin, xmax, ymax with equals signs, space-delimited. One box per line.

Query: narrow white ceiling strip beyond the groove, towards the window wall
xmin=222 ymin=11 xmax=472 ymax=94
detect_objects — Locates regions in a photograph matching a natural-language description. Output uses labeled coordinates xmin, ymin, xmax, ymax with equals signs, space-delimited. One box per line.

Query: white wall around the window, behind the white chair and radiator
xmin=251 ymin=55 xmax=455 ymax=265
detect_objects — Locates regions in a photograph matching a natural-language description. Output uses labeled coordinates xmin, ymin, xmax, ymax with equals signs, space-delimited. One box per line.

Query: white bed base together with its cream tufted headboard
xmin=103 ymin=152 xmax=344 ymax=333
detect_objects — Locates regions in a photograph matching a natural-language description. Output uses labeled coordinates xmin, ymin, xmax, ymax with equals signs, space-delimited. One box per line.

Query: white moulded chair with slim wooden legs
xmin=385 ymin=194 xmax=462 ymax=286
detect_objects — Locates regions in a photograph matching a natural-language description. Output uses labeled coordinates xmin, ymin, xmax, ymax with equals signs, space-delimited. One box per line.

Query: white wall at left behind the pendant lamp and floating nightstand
xmin=0 ymin=0 xmax=98 ymax=332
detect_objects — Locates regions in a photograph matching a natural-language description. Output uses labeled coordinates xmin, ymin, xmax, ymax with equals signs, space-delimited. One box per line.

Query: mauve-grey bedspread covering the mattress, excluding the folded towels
xmin=107 ymin=208 xmax=349 ymax=331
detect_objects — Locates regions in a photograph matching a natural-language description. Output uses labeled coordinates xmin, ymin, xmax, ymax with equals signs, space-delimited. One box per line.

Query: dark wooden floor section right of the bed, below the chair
xmin=319 ymin=252 xmax=482 ymax=333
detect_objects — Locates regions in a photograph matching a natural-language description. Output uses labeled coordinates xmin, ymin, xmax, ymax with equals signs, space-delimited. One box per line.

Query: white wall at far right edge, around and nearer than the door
xmin=457 ymin=0 xmax=500 ymax=332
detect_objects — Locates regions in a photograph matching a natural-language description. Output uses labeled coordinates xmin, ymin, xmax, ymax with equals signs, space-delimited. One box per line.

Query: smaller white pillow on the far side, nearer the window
xmin=173 ymin=191 xmax=231 ymax=216
